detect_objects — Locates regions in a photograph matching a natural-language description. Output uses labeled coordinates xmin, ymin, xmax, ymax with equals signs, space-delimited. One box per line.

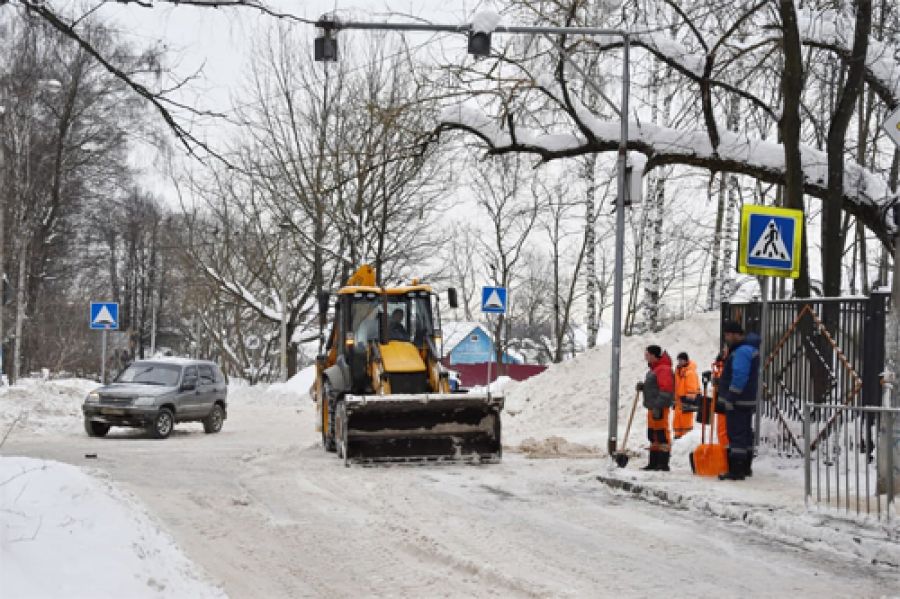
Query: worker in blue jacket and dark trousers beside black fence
xmin=719 ymin=320 xmax=760 ymax=480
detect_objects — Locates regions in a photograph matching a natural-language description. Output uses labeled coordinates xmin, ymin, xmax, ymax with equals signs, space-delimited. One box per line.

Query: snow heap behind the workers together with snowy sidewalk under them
xmin=503 ymin=312 xmax=900 ymax=565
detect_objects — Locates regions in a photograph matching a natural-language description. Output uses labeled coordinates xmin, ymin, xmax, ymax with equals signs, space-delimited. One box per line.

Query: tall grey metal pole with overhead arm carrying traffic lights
xmin=314 ymin=17 xmax=631 ymax=456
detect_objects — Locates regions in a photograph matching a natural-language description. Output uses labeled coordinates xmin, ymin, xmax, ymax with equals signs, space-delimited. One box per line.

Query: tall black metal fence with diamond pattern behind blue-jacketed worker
xmin=722 ymin=292 xmax=890 ymax=455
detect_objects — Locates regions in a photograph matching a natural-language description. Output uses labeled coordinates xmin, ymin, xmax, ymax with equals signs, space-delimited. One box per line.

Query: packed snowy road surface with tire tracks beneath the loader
xmin=3 ymin=404 xmax=900 ymax=598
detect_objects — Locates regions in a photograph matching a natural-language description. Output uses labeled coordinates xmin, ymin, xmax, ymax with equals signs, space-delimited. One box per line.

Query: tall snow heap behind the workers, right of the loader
xmin=503 ymin=312 xmax=719 ymax=454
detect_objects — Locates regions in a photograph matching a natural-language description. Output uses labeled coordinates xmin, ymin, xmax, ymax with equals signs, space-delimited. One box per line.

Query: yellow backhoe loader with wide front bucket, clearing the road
xmin=314 ymin=265 xmax=503 ymax=465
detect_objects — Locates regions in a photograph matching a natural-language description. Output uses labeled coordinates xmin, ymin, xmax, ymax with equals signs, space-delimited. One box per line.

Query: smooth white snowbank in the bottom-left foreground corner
xmin=0 ymin=457 xmax=225 ymax=598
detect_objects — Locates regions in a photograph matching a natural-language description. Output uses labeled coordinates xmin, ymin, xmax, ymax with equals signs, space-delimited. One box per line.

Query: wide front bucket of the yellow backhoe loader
xmin=339 ymin=393 xmax=503 ymax=462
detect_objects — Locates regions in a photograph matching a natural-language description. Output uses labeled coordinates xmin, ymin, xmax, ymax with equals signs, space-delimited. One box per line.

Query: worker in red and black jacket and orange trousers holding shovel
xmin=637 ymin=345 xmax=675 ymax=471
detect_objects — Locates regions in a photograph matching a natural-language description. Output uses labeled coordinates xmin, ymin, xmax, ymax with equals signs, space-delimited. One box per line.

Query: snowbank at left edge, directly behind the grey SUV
xmin=0 ymin=379 xmax=100 ymax=438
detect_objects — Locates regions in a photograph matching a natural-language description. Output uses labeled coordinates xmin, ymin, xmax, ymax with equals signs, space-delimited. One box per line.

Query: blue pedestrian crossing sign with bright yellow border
xmin=738 ymin=205 xmax=803 ymax=279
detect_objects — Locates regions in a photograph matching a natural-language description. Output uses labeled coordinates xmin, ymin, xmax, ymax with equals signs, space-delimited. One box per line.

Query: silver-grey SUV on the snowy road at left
xmin=81 ymin=358 xmax=228 ymax=439
